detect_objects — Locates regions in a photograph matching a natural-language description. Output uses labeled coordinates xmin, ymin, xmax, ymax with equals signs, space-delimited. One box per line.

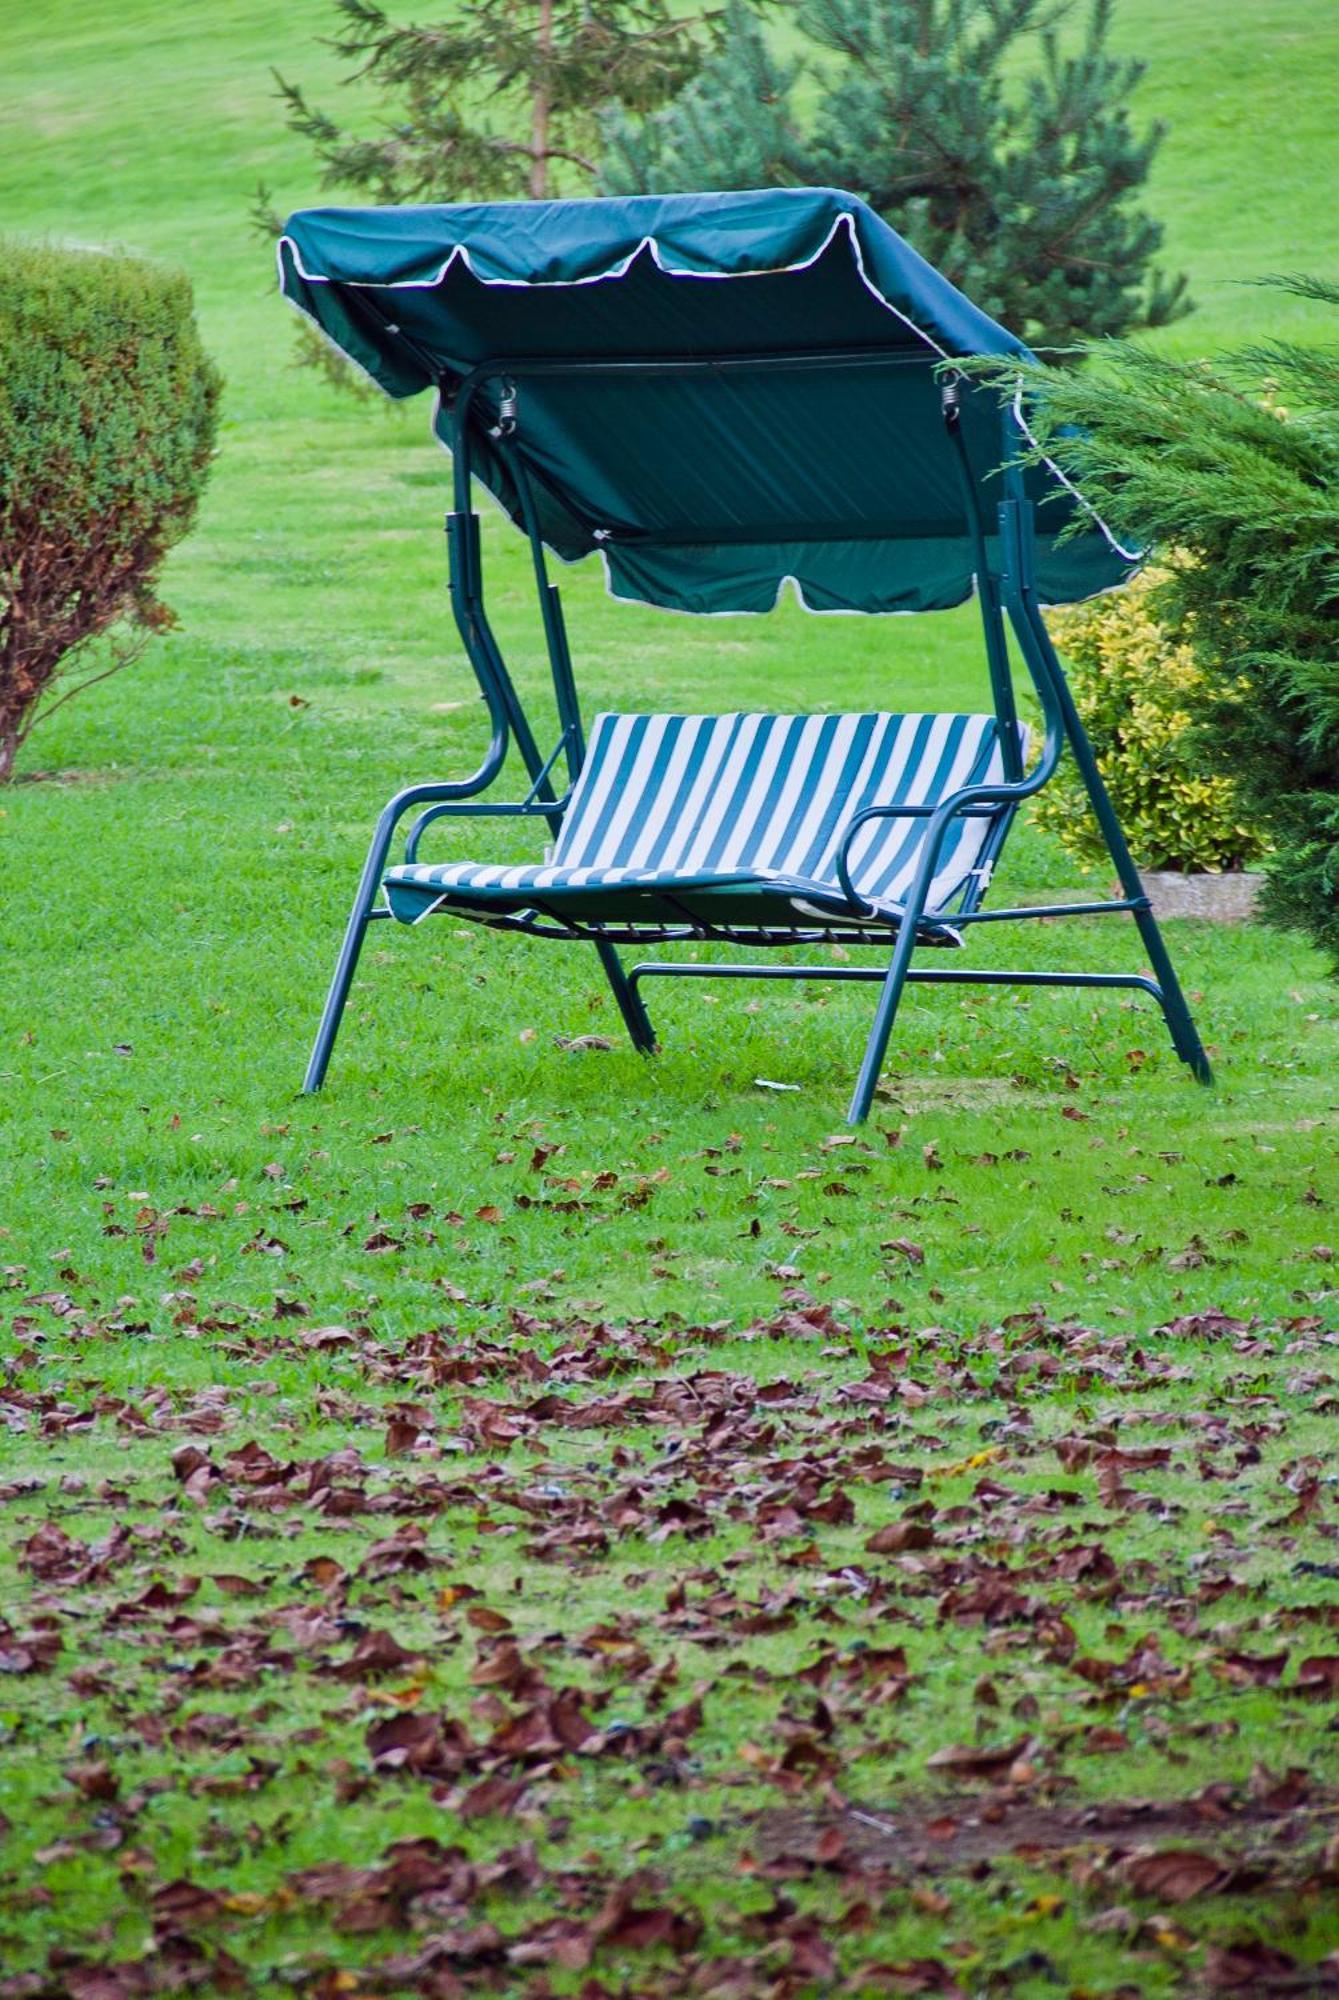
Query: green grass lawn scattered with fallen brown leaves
xmin=0 ymin=0 xmax=1339 ymax=2000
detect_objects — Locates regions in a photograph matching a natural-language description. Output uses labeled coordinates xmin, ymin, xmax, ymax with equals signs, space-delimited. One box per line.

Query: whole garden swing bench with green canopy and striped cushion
xmin=280 ymin=188 xmax=1209 ymax=1124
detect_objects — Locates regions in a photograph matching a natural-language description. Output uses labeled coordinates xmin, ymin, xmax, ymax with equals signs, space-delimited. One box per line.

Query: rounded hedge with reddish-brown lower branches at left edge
xmin=0 ymin=240 xmax=220 ymax=780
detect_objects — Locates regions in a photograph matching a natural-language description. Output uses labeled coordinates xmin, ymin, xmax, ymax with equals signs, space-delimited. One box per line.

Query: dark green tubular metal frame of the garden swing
xmin=304 ymin=344 xmax=1211 ymax=1124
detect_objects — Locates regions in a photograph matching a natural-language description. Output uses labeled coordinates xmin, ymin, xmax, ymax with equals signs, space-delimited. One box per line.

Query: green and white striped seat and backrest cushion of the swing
xmin=386 ymin=714 xmax=1025 ymax=922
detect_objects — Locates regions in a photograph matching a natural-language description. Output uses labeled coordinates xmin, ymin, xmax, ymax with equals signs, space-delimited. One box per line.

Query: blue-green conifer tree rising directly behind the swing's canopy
xmin=604 ymin=0 xmax=1189 ymax=348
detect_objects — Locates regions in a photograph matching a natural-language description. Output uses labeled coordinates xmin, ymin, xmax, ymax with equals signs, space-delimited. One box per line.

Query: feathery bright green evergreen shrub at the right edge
xmin=995 ymin=278 xmax=1339 ymax=968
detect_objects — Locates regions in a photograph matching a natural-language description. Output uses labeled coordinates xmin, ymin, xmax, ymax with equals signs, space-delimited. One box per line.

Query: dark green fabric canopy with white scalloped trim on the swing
xmin=280 ymin=188 xmax=1137 ymax=612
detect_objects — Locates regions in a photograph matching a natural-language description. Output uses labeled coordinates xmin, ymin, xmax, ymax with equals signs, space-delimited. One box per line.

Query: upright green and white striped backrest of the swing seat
xmin=554 ymin=714 xmax=1025 ymax=910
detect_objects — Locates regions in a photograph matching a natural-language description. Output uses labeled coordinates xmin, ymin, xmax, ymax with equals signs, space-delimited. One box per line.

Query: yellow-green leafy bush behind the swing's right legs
xmin=1035 ymin=568 xmax=1263 ymax=870
